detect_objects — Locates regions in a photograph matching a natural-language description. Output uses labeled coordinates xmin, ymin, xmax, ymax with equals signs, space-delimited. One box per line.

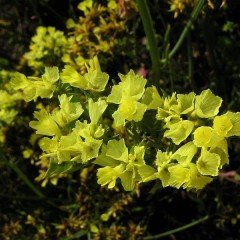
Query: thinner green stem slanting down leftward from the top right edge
xmin=165 ymin=0 xmax=206 ymax=61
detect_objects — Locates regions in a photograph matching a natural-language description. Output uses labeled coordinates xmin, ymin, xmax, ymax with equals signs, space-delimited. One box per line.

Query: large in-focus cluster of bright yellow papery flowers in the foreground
xmin=12 ymin=58 xmax=240 ymax=191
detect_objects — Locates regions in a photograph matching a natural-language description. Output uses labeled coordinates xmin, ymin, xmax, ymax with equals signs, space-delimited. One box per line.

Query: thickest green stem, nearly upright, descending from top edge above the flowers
xmin=136 ymin=0 xmax=160 ymax=83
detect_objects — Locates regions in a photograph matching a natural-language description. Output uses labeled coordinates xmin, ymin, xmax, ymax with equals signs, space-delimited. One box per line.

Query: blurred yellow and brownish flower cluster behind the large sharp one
xmin=22 ymin=0 xmax=137 ymax=75
